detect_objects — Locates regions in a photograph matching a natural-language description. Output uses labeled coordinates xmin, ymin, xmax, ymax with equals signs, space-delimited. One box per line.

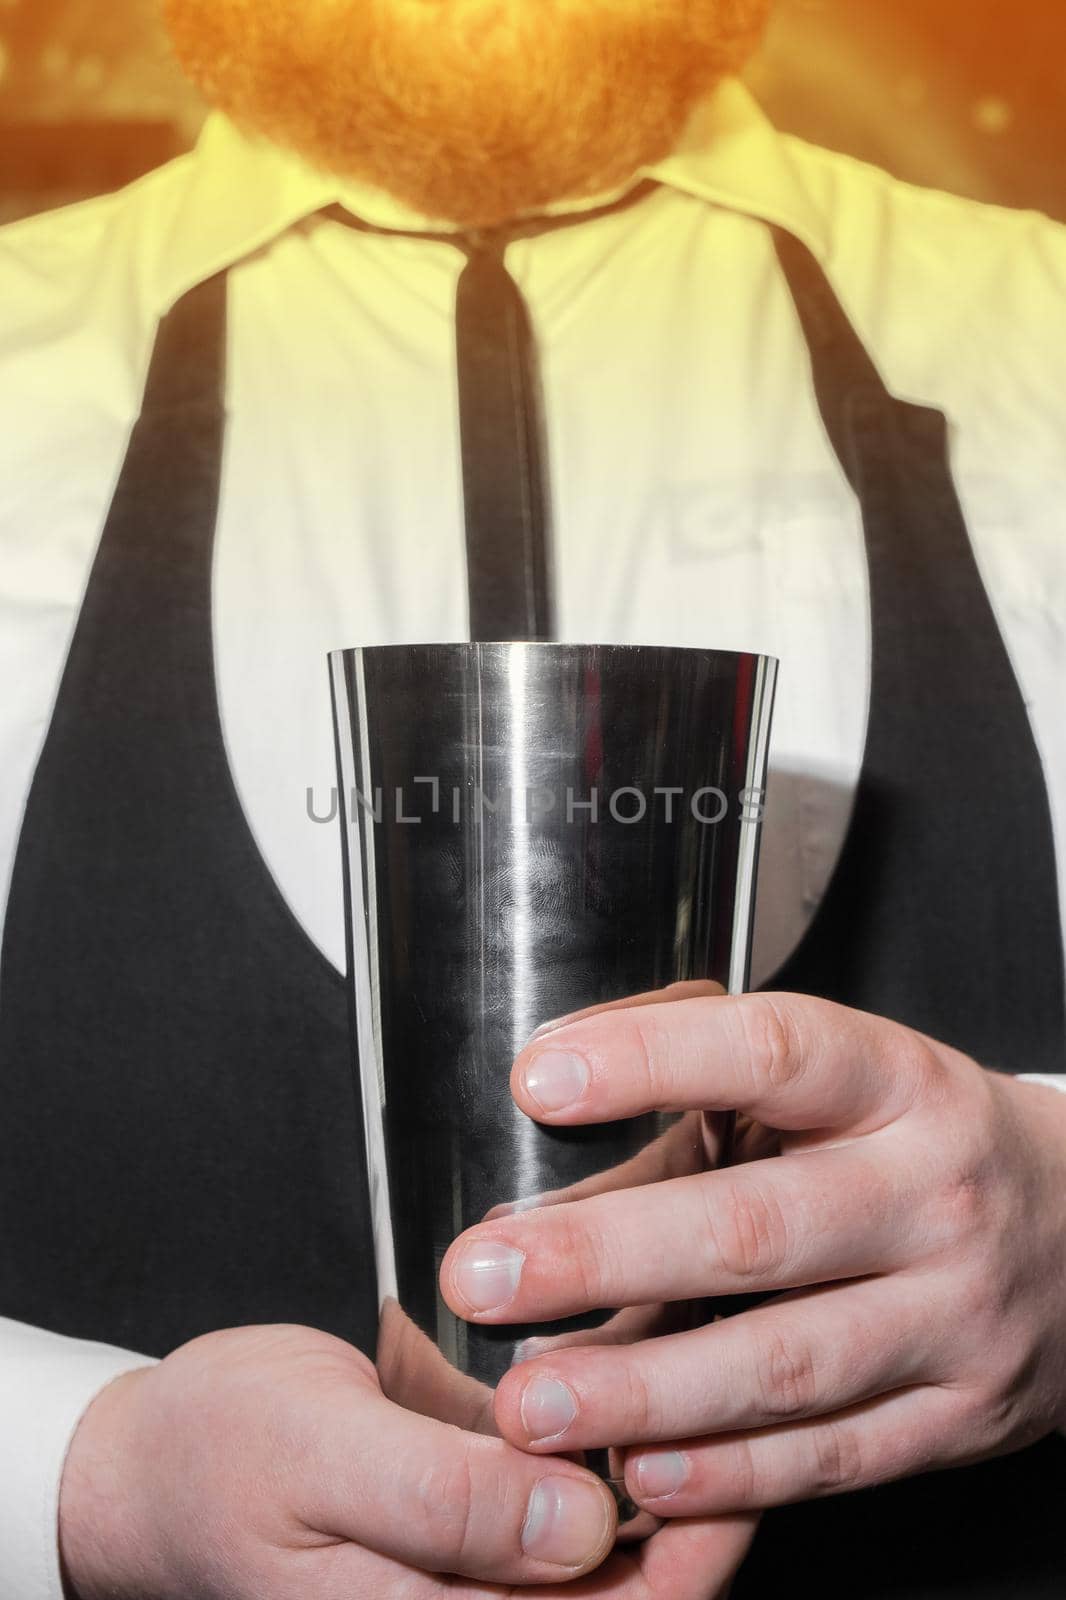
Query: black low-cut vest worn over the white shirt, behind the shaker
xmin=0 ymin=216 xmax=1066 ymax=1600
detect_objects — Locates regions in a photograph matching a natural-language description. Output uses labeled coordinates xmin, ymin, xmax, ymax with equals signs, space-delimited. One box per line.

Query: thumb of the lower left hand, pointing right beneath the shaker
xmin=299 ymin=1384 xmax=616 ymax=1584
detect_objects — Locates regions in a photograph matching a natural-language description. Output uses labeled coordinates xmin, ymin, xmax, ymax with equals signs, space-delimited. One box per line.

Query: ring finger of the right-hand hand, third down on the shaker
xmin=496 ymin=1277 xmax=938 ymax=1451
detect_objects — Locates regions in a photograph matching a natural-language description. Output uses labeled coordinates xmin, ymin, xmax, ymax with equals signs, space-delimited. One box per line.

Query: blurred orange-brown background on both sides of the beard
xmin=0 ymin=0 xmax=1066 ymax=221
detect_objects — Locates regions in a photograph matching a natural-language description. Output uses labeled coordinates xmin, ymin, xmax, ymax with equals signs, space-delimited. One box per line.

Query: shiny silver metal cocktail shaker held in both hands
xmin=330 ymin=643 xmax=776 ymax=1472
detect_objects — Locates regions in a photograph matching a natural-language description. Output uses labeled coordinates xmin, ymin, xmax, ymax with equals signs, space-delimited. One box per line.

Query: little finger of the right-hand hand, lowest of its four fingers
xmin=626 ymin=1386 xmax=965 ymax=1517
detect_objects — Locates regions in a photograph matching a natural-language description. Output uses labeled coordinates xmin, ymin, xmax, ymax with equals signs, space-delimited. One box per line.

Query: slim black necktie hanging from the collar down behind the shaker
xmin=325 ymin=179 xmax=656 ymax=640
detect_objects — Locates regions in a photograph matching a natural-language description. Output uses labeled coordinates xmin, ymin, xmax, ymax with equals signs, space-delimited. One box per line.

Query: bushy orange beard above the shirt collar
xmin=163 ymin=0 xmax=770 ymax=226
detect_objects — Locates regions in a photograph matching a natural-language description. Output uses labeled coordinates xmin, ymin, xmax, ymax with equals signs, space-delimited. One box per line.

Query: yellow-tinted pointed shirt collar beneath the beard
xmin=158 ymin=78 xmax=828 ymax=309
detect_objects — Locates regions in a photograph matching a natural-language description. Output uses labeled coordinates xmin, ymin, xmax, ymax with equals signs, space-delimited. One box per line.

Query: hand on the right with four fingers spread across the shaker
xmin=442 ymin=995 xmax=1066 ymax=1517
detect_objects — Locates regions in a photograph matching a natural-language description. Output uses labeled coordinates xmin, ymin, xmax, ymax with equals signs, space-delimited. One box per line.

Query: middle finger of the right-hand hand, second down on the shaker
xmin=440 ymin=1144 xmax=902 ymax=1323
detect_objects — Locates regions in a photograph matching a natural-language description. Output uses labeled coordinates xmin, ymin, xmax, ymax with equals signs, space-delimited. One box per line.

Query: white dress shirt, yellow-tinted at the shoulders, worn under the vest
xmin=0 ymin=83 xmax=1066 ymax=1600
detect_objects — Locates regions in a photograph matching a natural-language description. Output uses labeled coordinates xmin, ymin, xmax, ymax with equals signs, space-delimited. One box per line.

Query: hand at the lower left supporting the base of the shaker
xmin=59 ymin=1328 xmax=751 ymax=1600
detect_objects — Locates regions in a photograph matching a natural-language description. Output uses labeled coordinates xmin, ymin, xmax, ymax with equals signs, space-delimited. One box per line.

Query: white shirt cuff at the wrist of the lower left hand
xmin=0 ymin=1317 xmax=154 ymax=1600
